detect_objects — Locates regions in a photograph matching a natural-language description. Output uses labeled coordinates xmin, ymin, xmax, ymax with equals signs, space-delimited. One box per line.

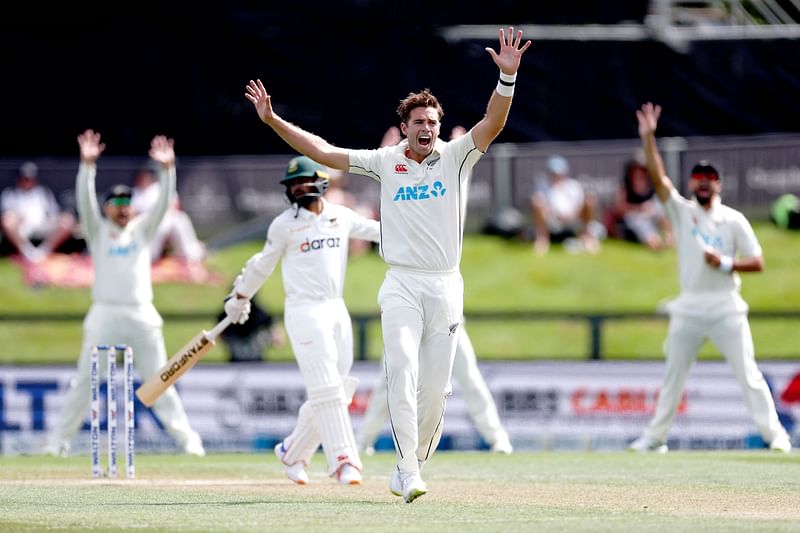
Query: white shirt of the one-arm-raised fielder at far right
xmin=664 ymin=189 xmax=762 ymax=316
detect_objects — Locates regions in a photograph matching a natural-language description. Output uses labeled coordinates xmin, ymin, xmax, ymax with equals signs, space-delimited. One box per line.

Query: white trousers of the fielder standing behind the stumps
xmin=49 ymin=303 xmax=199 ymax=448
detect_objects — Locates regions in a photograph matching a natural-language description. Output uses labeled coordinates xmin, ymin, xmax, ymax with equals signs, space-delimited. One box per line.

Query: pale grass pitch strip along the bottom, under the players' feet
xmin=0 ymin=451 xmax=800 ymax=533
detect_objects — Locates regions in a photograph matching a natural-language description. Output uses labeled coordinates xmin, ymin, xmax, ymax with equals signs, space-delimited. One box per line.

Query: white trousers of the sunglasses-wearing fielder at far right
xmin=645 ymin=313 xmax=786 ymax=443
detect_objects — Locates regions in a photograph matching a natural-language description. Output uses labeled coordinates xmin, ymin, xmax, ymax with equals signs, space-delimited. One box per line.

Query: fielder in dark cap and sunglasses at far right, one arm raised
xmin=630 ymin=103 xmax=792 ymax=453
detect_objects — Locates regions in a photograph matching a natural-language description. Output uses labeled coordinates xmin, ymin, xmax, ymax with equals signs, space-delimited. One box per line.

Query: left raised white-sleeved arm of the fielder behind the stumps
xmin=75 ymin=130 xmax=106 ymax=240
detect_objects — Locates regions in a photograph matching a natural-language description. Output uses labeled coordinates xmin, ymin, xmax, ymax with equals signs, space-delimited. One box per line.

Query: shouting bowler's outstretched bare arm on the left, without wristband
xmin=244 ymin=80 xmax=350 ymax=171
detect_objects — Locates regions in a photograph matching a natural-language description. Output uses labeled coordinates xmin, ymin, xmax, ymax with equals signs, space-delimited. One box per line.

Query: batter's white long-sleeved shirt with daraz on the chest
xmin=235 ymin=200 xmax=380 ymax=305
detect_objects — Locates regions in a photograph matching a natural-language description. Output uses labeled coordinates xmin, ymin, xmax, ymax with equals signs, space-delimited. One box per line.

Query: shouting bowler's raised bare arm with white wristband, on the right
xmin=472 ymin=28 xmax=531 ymax=152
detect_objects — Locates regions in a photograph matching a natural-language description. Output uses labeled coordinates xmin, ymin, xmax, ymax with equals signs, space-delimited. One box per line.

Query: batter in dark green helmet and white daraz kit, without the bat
xmin=225 ymin=156 xmax=380 ymax=485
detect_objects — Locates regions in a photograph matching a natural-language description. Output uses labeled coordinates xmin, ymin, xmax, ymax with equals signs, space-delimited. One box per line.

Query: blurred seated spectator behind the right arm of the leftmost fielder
xmin=131 ymin=163 xmax=206 ymax=262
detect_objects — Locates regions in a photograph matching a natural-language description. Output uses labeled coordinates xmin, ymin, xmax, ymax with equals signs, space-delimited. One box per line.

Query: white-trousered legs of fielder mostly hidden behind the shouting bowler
xmin=356 ymin=321 xmax=514 ymax=453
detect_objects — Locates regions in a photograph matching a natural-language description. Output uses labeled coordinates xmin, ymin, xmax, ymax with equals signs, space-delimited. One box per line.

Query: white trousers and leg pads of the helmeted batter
xmin=283 ymin=298 xmax=362 ymax=475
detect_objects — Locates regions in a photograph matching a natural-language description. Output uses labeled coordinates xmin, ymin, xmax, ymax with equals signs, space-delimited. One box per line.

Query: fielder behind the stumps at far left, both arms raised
xmin=45 ymin=130 xmax=205 ymax=456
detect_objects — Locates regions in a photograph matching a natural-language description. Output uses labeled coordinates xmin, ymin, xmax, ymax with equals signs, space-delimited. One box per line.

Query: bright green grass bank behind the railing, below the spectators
xmin=0 ymin=222 xmax=800 ymax=364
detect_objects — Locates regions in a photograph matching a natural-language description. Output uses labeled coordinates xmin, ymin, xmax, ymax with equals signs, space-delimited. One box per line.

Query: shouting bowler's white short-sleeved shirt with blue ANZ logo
xmin=350 ymin=132 xmax=483 ymax=272
